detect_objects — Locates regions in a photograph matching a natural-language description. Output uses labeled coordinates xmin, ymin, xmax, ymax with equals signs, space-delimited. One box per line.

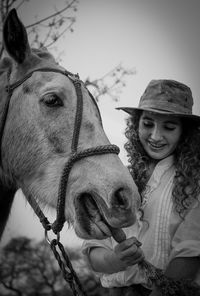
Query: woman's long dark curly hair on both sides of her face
xmin=124 ymin=110 xmax=200 ymax=217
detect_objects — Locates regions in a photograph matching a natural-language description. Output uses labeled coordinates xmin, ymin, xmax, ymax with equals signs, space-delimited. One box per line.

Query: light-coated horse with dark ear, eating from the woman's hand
xmin=0 ymin=9 xmax=139 ymax=245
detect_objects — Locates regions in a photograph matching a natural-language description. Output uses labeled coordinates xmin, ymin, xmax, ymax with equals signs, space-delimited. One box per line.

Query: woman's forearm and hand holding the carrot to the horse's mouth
xmin=89 ymin=237 xmax=144 ymax=274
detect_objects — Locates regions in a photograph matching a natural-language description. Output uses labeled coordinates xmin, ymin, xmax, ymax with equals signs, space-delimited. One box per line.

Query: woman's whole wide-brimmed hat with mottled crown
xmin=116 ymin=79 xmax=200 ymax=124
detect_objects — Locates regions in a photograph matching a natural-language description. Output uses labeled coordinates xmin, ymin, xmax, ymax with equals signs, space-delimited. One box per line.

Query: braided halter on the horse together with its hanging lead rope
xmin=0 ymin=67 xmax=119 ymax=295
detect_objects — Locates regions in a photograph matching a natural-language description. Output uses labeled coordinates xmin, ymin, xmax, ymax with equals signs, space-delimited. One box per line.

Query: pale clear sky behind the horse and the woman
xmin=2 ymin=0 xmax=200 ymax=246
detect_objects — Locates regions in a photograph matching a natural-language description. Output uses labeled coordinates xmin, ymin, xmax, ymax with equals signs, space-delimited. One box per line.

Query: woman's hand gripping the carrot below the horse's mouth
xmin=114 ymin=237 xmax=144 ymax=268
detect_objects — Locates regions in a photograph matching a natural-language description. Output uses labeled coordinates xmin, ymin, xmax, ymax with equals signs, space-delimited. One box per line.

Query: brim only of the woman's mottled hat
xmin=115 ymin=107 xmax=200 ymax=124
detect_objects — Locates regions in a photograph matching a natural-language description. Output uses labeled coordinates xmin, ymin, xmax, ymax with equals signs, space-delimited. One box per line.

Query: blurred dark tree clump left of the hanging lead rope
xmin=0 ymin=237 xmax=62 ymax=296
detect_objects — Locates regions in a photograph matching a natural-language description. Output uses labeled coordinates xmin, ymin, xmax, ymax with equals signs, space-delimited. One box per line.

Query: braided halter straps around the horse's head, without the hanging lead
xmin=0 ymin=67 xmax=119 ymax=234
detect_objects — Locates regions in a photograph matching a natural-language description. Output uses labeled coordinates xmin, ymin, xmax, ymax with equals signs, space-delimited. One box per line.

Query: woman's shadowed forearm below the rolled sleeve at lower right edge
xmin=150 ymin=257 xmax=200 ymax=296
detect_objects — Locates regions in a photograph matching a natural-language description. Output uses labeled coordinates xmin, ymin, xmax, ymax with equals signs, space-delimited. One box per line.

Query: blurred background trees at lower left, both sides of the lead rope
xmin=0 ymin=237 xmax=107 ymax=296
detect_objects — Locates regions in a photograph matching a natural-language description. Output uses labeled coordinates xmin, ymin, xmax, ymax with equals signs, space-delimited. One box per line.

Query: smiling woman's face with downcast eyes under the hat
xmin=139 ymin=111 xmax=182 ymax=160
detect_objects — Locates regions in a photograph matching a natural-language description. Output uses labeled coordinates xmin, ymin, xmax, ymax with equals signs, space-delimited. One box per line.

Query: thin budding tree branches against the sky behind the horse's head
xmin=0 ymin=0 xmax=136 ymax=101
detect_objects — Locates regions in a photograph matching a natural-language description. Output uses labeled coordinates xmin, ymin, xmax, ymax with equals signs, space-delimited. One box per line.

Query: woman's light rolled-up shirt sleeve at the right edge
xmin=169 ymin=201 xmax=200 ymax=261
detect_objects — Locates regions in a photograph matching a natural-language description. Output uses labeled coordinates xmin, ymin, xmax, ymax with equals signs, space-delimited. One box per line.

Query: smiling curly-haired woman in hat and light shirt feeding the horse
xmin=83 ymin=79 xmax=200 ymax=296
